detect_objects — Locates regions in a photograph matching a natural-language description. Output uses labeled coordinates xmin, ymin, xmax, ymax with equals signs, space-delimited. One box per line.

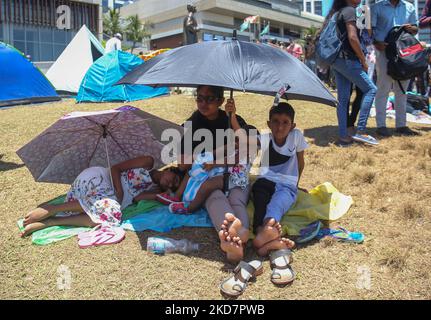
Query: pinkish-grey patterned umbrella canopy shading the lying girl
xmin=17 ymin=107 xmax=183 ymax=184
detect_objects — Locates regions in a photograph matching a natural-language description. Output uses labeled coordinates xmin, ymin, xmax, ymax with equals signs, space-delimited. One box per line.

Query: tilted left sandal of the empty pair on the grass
xmin=220 ymin=260 xmax=263 ymax=297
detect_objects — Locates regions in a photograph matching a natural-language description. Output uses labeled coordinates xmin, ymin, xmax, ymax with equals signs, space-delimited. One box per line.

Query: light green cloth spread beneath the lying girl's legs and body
xmin=18 ymin=195 xmax=162 ymax=246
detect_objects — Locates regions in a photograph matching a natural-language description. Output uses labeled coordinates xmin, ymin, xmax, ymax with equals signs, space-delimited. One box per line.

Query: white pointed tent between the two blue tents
xmin=46 ymin=25 xmax=104 ymax=94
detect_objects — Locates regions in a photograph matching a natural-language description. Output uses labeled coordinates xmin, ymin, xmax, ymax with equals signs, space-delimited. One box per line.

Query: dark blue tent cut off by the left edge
xmin=0 ymin=42 xmax=60 ymax=107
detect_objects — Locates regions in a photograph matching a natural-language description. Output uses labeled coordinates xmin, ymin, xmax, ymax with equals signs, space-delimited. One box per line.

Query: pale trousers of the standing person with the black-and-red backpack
xmin=375 ymin=51 xmax=409 ymax=128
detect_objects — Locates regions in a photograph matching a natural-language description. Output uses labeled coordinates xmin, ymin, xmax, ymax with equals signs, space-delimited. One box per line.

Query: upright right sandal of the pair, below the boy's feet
xmin=269 ymin=249 xmax=296 ymax=285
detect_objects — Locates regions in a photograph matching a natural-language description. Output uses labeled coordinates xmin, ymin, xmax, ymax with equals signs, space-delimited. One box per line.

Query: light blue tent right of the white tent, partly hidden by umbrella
xmin=76 ymin=50 xmax=169 ymax=102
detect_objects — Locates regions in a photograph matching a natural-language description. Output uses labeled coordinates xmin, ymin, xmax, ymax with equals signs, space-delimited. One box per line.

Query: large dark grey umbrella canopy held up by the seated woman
xmin=117 ymin=40 xmax=337 ymax=106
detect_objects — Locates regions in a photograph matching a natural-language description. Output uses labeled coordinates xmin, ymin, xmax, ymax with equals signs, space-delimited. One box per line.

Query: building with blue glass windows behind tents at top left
xmin=0 ymin=0 xmax=103 ymax=62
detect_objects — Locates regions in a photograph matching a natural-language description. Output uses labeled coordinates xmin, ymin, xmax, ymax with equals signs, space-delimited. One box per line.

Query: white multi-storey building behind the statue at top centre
xmin=120 ymin=0 xmax=323 ymax=48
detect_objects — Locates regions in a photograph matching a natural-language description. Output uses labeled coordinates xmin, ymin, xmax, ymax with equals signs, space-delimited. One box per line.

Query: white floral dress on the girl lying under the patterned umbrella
xmin=66 ymin=167 xmax=154 ymax=226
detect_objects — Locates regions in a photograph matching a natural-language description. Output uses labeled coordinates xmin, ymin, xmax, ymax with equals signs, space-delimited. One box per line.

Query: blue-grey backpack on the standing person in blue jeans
xmin=315 ymin=13 xmax=345 ymax=69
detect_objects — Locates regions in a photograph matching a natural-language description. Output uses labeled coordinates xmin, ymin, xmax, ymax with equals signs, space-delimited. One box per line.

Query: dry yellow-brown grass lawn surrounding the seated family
xmin=0 ymin=93 xmax=431 ymax=300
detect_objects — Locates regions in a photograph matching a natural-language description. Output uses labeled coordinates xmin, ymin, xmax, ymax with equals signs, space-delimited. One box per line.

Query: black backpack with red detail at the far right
xmin=385 ymin=26 xmax=428 ymax=89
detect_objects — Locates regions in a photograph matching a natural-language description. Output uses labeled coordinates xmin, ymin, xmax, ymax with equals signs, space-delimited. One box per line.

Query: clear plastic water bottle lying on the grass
xmin=147 ymin=237 xmax=199 ymax=254
